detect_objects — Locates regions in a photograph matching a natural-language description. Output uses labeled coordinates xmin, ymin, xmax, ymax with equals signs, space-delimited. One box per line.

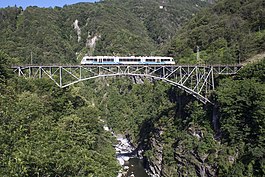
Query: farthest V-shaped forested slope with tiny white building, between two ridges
xmin=103 ymin=0 xmax=208 ymax=44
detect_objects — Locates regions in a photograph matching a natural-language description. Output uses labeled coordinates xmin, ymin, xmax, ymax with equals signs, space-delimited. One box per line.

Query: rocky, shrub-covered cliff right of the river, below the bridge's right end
xmin=131 ymin=93 xmax=222 ymax=177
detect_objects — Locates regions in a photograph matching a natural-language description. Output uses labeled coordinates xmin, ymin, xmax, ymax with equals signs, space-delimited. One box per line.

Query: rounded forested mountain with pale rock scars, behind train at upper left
xmin=1 ymin=3 xmax=154 ymax=63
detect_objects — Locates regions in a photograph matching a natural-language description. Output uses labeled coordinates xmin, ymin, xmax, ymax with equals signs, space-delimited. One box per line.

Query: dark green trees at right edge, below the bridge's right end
xmin=214 ymin=62 xmax=265 ymax=176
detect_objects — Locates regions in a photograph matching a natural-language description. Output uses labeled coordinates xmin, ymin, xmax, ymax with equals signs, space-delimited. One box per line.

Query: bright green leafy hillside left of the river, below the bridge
xmin=0 ymin=52 xmax=120 ymax=177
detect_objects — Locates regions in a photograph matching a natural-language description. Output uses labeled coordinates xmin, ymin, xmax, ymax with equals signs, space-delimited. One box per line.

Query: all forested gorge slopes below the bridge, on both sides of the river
xmin=0 ymin=53 xmax=265 ymax=177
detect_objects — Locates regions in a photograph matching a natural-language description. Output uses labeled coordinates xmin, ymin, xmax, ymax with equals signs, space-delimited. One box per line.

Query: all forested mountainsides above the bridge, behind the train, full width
xmin=0 ymin=0 xmax=265 ymax=63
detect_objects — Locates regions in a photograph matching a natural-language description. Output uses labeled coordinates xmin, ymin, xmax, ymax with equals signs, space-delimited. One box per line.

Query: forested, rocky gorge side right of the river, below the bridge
xmin=92 ymin=60 xmax=265 ymax=177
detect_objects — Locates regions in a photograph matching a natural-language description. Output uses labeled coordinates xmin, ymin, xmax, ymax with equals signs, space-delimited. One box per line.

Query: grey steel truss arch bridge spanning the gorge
xmin=12 ymin=65 xmax=242 ymax=104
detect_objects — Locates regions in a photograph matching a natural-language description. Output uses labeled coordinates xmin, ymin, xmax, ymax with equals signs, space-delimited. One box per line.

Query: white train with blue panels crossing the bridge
xmin=81 ymin=56 xmax=175 ymax=65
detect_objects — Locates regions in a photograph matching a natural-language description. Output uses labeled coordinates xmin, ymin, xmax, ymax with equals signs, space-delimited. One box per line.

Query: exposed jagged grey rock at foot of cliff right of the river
xmin=144 ymin=125 xmax=218 ymax=177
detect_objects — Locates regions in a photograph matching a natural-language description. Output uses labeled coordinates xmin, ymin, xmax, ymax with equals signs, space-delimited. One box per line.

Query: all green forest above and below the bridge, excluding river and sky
xmin=0 ymin=0 xmax=265 ymax=177
